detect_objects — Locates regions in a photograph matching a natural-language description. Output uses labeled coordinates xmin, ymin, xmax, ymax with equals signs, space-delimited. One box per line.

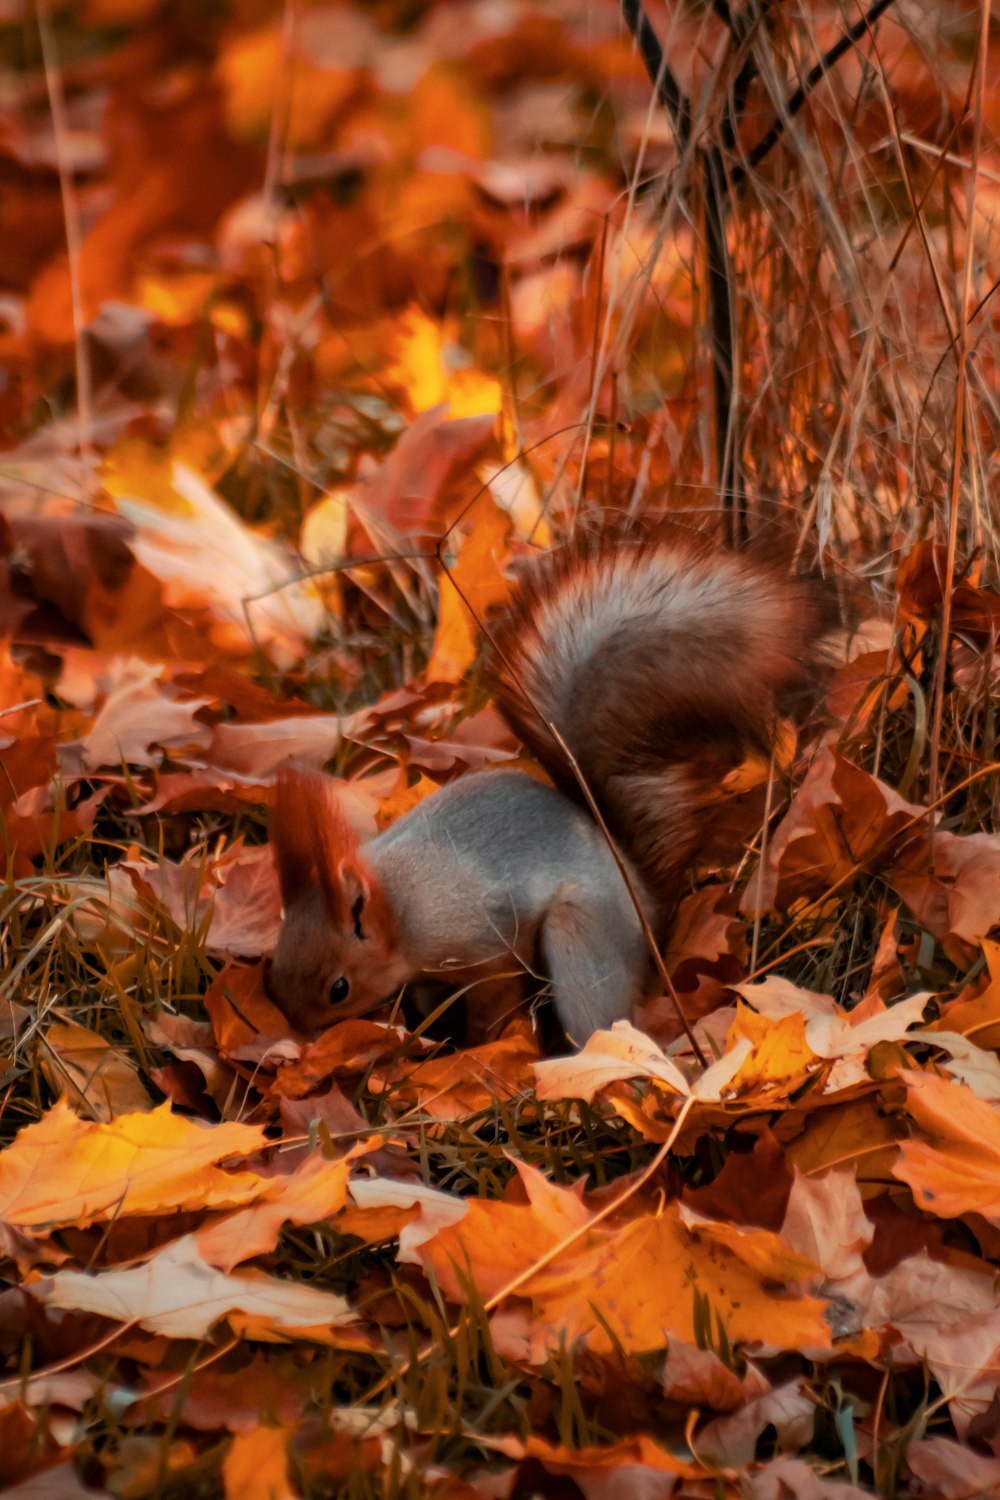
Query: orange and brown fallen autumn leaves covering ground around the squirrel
xmin=0 ymin=0 xmax=1000 ymax=1500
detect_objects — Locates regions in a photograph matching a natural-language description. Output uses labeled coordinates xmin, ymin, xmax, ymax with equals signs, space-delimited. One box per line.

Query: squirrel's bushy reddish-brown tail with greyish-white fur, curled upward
xmin=490 ymin=534 xmax=835 ymax=905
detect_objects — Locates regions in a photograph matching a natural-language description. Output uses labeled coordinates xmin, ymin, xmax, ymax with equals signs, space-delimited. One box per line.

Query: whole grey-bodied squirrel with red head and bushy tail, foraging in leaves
xmin=270 ymin=534 xmax=832 ymax=1043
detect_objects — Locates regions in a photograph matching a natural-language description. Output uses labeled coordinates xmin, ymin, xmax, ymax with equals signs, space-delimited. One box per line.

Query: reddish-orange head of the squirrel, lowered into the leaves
xmin=268 ymin=768 xmax=408 ymax=1034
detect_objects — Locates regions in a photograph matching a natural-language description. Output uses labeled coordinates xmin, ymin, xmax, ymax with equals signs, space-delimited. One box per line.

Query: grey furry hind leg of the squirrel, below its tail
xmin=541 ymin=882 xmax=649 ymax=1046
